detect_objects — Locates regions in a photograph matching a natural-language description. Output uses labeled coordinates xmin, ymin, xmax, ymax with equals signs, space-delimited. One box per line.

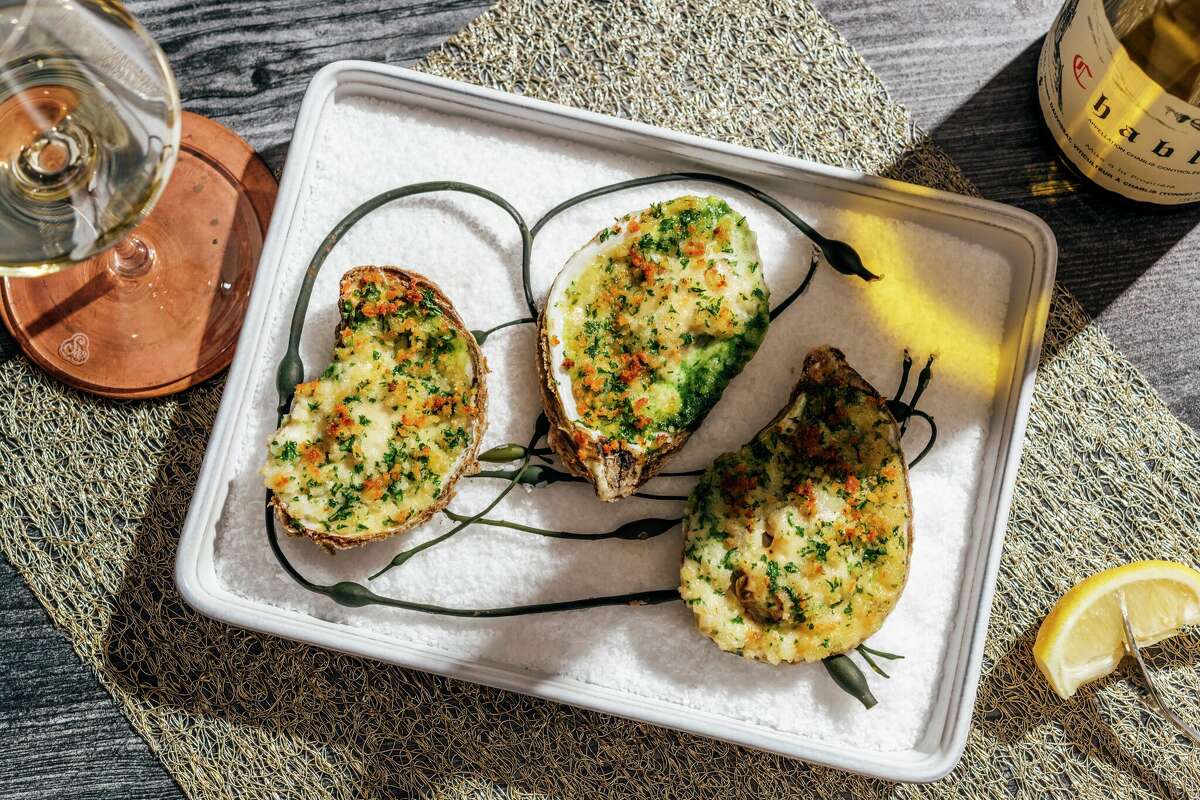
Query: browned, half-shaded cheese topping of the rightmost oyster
xmin=679 ymin=376 xmax=910 ymax=663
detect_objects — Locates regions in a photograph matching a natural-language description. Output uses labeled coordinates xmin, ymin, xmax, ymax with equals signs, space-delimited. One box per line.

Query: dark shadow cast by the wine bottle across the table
xmin=884 ymin=40 xmax=1200 ymax=333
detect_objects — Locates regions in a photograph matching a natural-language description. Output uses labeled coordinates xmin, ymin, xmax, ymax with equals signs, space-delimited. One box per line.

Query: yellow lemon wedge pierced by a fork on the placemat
xmin=1033 ymin=561 xmax=1200 ymax=698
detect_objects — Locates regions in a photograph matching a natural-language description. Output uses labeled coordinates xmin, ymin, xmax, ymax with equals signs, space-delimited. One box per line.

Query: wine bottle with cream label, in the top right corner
xmin=1038 ymin=0 xmax=1200 ymax=205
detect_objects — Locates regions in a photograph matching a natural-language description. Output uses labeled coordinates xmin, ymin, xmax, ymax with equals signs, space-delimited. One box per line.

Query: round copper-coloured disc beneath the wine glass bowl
xmin=0 ymin=112 xmax=278 ymax=398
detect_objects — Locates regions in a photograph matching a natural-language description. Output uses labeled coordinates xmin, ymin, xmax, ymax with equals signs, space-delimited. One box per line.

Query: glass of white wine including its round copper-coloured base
xmin=0 ymin=0 xmax=276 ymax=397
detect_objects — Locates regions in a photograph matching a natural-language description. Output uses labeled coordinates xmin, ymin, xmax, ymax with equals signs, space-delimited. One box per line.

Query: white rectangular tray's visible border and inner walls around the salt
xmin=175 ymin=61 xmax=1056 ymax=781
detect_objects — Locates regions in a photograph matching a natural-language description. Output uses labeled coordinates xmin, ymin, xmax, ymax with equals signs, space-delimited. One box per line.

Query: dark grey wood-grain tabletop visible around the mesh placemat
xmin=0 ymin=0 xmax=1200 ymax=800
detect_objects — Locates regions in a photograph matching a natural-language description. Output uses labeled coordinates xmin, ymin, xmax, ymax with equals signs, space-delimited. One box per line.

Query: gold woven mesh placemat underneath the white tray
xmin=0 ymin=0 xmax=1200 ymax=800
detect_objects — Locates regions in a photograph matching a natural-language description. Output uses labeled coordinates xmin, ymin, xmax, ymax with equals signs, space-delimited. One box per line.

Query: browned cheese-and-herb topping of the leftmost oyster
xmin=263 ymin=271 xmax=478 ymax=536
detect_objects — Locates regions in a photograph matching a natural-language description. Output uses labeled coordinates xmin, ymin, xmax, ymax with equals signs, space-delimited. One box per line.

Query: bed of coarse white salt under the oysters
xmin=215 ymin=97 xmax=1009 ymax=752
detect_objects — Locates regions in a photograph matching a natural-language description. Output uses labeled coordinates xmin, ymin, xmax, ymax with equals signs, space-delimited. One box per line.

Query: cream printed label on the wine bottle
xmin=1038 ymin=0 xmax=1200 ymax=204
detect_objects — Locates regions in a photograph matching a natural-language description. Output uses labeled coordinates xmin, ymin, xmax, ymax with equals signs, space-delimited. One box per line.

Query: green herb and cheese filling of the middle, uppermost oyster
xmin=548 ymin=196 xmax=769 ymax=447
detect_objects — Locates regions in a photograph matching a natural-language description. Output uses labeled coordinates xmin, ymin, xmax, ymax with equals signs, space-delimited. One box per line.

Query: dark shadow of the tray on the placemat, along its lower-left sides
xmin=102 ymin=393 xmax=889 ymax=798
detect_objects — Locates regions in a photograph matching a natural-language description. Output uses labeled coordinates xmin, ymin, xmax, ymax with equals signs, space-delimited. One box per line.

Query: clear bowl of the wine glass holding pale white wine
xmin=0 ymin=0 xmax=180 ymax=276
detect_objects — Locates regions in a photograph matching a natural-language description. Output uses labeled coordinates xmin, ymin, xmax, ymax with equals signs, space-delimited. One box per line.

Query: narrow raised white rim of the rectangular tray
xmin=175 ymin=60 xmax=1057 ymax=782
